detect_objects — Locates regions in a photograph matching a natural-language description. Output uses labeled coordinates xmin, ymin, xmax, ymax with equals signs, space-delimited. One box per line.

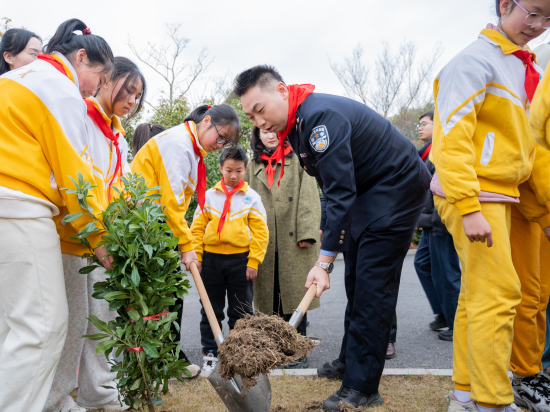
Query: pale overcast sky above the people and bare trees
xmin=4 ymin=0 xmax=550 ymax=112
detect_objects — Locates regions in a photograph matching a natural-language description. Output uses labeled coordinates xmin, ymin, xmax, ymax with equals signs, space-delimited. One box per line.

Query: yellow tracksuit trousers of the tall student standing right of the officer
xmin=434 ymin=196 xmax=521 ymax=407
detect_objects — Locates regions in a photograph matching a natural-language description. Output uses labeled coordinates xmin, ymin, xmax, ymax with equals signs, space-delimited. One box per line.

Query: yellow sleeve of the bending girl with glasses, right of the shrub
xmin=131 ymin=138 xmax=193 ymax=252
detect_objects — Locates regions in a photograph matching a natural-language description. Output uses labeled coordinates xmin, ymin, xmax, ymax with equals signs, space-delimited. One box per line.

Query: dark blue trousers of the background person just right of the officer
xmin=414 ymin=230 xmax=461 ymax=329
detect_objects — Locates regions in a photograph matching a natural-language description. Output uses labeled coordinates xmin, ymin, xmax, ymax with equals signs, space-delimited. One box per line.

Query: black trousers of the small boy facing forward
xmin=200 ymin=252 xmax=254 ymax=355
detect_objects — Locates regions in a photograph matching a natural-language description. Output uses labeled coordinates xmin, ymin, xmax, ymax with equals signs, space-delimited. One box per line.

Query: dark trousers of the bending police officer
xmin=340 ymin=195 xmax=426 ymax=394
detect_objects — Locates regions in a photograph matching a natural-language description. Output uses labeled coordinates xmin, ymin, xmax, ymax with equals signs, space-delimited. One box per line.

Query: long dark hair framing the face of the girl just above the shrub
xmin=96 ymin=56 xmax=147 ymax=121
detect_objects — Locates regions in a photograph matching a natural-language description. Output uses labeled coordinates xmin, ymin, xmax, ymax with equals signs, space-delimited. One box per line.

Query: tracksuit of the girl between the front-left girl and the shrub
xmin=43 ymin=97 xmax=130 ymax=412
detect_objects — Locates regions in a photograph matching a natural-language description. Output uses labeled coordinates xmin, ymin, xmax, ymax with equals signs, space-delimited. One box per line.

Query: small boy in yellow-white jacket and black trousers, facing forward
xmin=191 ymin=147 xmax=269 ymax=371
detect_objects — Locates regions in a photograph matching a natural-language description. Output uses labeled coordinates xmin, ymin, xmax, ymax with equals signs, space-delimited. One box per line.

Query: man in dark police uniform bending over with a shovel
xmin=235 ymin=66 xmax=431 ymax=411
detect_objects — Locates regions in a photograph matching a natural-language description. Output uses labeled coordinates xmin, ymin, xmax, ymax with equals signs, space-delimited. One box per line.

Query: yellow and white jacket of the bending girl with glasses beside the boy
xmin=130 ymin=122 xmax=206 ymax=252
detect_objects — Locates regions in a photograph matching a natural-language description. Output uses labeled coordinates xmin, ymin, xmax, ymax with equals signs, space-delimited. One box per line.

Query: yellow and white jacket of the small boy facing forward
xmin=191 ymin=181 xmax=269 ymax=269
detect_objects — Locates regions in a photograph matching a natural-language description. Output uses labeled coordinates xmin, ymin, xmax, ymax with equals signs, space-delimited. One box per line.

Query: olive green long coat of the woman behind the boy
xmin=244 ymin=155 xmax=321 ymax=315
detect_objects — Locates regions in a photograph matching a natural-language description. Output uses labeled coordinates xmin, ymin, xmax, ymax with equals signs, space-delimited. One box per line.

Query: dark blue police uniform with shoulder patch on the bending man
xmin=288 ymin=93 xmax=431 ymax=394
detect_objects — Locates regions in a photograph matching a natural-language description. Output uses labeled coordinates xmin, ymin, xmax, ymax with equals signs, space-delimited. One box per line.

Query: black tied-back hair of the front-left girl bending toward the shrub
xmin=43 ymin=19 xmax=114 ymax=73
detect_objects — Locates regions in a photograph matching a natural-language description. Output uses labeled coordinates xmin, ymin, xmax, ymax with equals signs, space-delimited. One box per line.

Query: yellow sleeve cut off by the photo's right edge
xmin=529 ymin=70 xmax=550 ymax=150
